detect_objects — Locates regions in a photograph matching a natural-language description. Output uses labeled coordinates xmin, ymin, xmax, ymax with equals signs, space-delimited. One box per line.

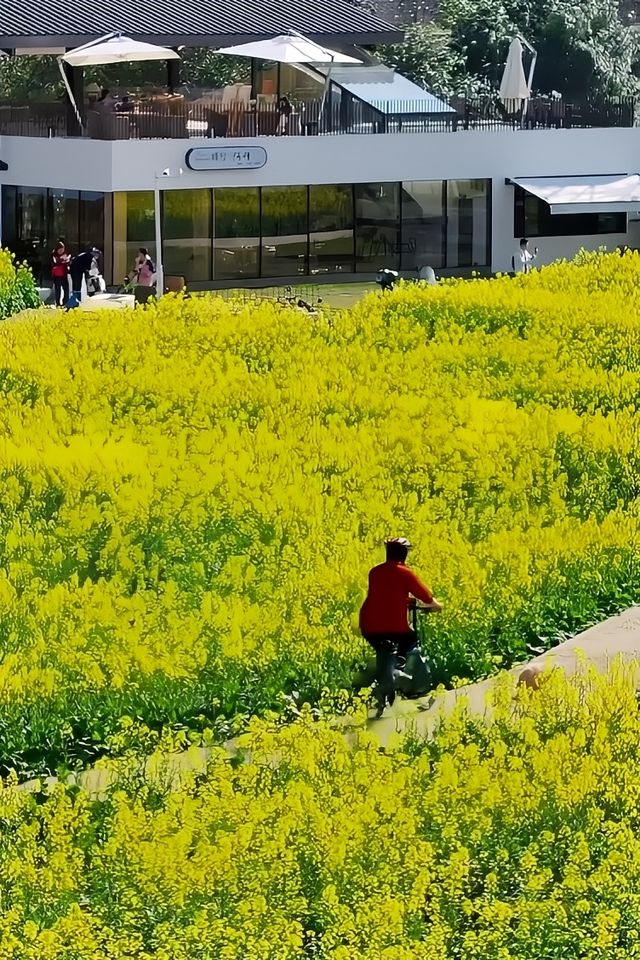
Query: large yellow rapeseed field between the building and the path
xmin=0 ymin=255 xmax=640 ymax=776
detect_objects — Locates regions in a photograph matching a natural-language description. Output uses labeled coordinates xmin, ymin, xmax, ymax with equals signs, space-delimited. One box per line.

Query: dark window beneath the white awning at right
xmin=513 ymin=187 xmax=627 ymax=237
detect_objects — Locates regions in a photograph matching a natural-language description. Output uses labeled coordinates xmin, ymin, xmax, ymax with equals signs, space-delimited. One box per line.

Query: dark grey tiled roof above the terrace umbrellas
xmin=0 ymin=0 xmax=402 ymax=50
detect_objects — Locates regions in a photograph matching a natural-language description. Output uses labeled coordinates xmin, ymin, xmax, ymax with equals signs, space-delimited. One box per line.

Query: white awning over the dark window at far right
xmin=510 ymin=174 xmax=640 ymax=213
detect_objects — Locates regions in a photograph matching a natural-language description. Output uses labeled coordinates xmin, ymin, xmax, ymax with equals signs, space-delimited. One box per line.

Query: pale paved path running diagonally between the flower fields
xmin=19 ymin=606 xmax=640 ymax=797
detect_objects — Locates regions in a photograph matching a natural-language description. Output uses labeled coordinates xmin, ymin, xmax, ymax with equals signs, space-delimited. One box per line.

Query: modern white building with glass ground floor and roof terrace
xmin=0 ymin=0 xmax=640 ymax=288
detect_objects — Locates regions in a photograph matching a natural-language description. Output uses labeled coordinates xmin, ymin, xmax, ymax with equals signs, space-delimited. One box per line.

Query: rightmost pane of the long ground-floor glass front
xmin=446 ymin=180 xmax=491 ymax=267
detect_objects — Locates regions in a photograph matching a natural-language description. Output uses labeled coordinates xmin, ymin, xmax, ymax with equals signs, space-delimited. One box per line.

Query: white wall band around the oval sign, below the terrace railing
xmin=0 ymin=128 xmax=640 ymax=270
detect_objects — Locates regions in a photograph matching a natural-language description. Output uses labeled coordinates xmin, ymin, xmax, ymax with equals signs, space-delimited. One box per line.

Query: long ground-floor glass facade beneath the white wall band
xmin=2 ymin=180 xmax=491 ymax=284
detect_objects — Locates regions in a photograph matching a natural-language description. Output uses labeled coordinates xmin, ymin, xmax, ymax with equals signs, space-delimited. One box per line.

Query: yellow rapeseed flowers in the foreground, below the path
xmin=0 ymin=671 xmax=640 ymax=960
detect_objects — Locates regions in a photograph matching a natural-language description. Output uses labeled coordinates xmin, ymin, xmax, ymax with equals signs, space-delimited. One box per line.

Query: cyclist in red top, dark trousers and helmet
xmin=360 ymin=537 xmax=442 ymax=717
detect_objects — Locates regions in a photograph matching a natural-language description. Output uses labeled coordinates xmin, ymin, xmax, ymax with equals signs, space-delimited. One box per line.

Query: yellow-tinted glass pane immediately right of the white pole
xmin=162 ymin=190 xmax=212 ymax=282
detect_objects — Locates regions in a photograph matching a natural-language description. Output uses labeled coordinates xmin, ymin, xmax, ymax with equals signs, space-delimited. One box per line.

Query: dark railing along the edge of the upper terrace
xmin=0 ymin=97 xmax=640 ymax=140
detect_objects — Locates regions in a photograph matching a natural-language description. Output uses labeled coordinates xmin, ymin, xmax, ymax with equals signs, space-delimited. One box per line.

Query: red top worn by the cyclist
xmin=360 ymin=560 xmax=433 ymax=636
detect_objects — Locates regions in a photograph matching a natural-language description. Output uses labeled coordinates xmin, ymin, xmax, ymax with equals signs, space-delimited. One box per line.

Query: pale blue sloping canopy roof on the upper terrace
xmin=317 ymin=63 xmax=456 ymax=115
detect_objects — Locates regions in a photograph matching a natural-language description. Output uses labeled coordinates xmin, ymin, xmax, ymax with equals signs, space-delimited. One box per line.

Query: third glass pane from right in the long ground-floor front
xmin=354 ymin=183 xmax=400 ymax=273
